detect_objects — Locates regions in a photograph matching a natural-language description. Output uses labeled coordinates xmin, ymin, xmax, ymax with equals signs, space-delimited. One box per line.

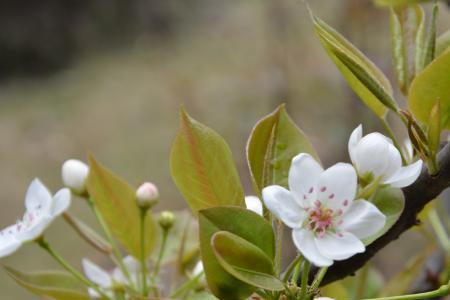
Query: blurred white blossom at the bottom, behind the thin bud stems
xmin=82 ymin=256 xmax=141 ymax=299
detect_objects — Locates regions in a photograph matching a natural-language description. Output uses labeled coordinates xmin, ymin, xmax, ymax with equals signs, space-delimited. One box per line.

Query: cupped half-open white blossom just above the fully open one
xmin=348 ymin=125 xmax=422 ymax=188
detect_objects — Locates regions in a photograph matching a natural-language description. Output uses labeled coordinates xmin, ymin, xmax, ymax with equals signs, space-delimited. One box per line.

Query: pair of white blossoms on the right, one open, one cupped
xmin=263 ymin=125 xmax=422 ymax=267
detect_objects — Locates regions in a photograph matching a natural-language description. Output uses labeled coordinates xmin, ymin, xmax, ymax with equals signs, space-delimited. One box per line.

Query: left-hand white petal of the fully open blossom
xmin=262 ymin=185 xmax=306 ymax=228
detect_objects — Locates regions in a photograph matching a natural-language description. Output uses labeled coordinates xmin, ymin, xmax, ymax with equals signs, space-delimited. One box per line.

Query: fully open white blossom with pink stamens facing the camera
xmin=263 ymin=153 xmax=386 ymax=267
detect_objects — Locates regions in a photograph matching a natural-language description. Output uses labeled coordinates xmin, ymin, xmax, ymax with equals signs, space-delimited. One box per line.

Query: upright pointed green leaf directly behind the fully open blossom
xmin=247 ymin=105 xmax=319 ymax=195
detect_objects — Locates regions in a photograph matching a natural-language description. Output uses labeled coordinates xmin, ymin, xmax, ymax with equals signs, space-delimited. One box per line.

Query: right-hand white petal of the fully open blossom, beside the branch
xmin=339 ymin=200 xmax=386 ymax=239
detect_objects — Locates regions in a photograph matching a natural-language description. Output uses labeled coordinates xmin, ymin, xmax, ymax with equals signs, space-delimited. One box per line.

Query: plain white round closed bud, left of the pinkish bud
xmin=61 ymin=159 xmax=89 ymax=194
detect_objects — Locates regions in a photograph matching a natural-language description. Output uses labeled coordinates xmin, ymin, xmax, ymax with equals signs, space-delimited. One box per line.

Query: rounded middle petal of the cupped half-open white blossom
xmin=353 ymin=132 xmax=390 ymax=177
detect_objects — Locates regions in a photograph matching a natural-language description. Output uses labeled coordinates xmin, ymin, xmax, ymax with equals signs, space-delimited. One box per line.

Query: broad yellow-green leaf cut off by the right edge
xmin=408 ymin=51 xmax=450 ymax=129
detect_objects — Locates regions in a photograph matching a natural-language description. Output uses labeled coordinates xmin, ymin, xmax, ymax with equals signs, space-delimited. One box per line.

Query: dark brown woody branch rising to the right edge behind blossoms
xmin=322 ymin=143 xmax=450 ymax=284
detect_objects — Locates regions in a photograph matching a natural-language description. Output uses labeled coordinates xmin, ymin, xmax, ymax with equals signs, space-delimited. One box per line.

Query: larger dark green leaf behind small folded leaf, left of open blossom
xmin=199 ymin=206 xmax=275 ymax=300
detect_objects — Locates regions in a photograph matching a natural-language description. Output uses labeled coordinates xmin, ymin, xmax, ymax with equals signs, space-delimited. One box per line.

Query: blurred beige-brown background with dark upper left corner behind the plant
xmin=0 ymin=0 xmax=450 ymax=300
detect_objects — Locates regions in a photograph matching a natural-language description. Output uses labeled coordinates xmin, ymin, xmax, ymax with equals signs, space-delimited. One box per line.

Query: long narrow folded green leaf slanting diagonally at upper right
xmin=314 ymin=17 xmax=397 ymax=118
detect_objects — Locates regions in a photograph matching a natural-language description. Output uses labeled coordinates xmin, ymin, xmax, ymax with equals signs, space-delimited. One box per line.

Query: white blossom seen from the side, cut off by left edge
xmin=0 ymin=179 xmax=70 ymax=257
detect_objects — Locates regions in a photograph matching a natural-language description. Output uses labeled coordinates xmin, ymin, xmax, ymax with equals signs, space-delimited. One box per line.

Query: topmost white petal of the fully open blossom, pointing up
xmin=289 ymin=153 xmax=323 ymax=207
